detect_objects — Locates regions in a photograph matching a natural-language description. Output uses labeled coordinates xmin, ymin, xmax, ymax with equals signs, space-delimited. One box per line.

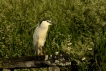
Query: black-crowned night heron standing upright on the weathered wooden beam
xmin=33 ymin=19 xmax=53 ymax=55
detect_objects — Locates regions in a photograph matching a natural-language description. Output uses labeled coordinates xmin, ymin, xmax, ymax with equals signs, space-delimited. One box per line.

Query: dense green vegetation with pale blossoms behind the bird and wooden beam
xmin=0 ymin=0 xmax=106 ymax=71
